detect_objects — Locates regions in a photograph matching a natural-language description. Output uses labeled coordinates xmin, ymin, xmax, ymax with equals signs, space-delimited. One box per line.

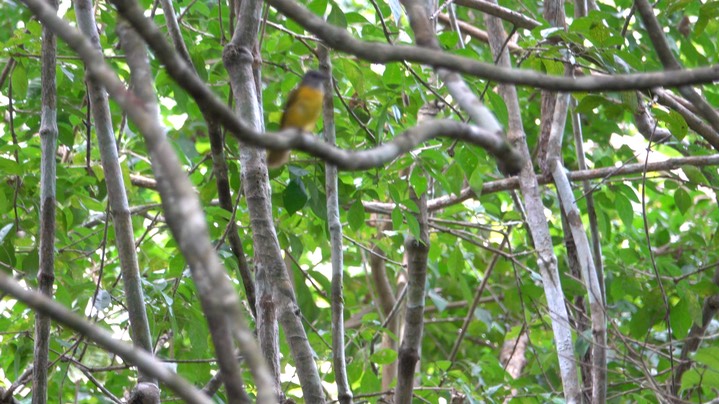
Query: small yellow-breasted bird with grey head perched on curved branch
xmin=267 ymin=70 xmax=327 ymax=168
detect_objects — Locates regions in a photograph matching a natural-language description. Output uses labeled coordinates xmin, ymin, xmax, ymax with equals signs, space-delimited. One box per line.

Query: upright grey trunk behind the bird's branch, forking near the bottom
xmin=222 ymin=0 xmax=325 ymax=404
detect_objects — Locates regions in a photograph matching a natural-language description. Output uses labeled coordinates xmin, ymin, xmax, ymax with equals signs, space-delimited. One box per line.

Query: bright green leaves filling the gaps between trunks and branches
xmin=0 ymin=0 xmax=719 ymax=402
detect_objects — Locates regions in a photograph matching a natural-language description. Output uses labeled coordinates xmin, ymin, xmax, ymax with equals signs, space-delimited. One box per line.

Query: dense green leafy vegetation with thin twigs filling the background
xmin=0 ymin=0 xmax=719 ymax=403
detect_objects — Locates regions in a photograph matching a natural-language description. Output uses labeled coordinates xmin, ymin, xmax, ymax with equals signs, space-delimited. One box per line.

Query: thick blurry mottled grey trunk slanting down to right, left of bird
xmin=117 ymin=21 xmax=255 ymax=403
